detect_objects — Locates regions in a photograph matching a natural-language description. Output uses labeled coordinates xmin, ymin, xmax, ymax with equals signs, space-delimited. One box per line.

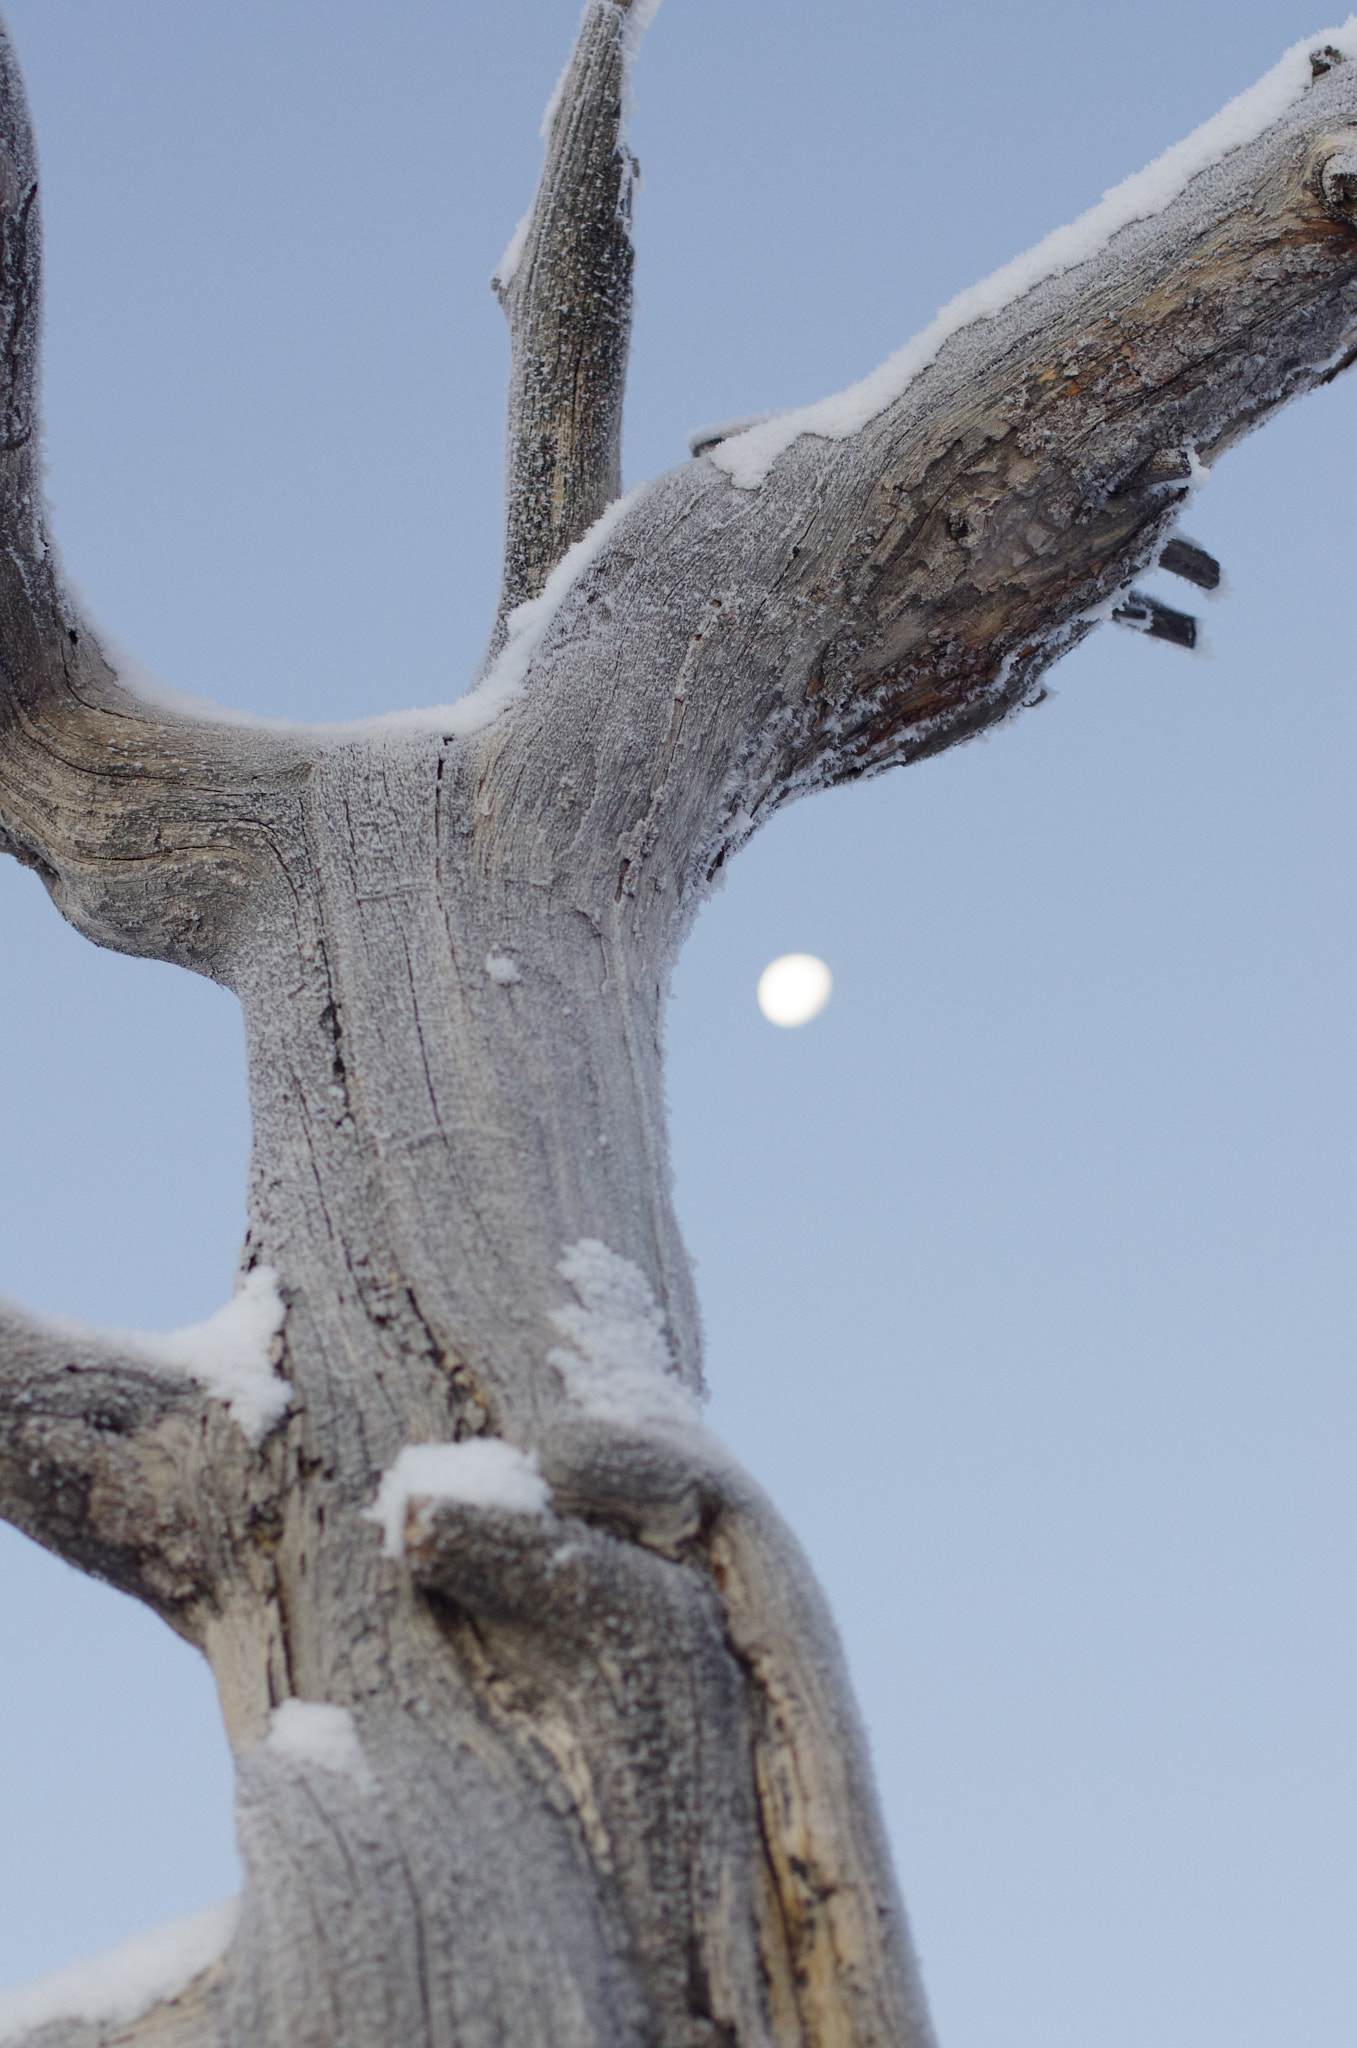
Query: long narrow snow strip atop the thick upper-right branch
xmin=710 ymin=14 xmax=1357 ymax=489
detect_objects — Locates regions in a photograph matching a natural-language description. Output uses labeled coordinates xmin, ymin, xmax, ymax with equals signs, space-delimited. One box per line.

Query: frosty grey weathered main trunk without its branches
xmin=209 ymin=735 xmax=925 ymax=2044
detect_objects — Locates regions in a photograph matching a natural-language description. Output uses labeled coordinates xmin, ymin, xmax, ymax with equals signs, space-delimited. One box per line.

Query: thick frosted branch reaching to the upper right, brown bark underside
xmin=480 ymin=48 xmax=1357 ymax=934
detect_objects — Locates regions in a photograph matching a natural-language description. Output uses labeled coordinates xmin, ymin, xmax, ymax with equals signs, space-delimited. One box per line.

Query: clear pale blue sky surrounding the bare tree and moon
xmin=0 ymin=0 xmax=1357 ymax=2048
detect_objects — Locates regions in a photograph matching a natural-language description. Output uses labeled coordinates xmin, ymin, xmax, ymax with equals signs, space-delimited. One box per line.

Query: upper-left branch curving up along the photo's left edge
xmin=0 ymin=27 xmax=313 ymax=971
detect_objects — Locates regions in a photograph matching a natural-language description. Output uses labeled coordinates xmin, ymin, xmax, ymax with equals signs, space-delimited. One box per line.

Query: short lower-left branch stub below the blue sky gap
xmin=0 ymin=1300 xmax=244 ymax=1645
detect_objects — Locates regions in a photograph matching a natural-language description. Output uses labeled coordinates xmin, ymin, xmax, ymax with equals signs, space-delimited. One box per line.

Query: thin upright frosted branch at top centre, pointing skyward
xmin=491 ymin=0 xmax=651 ymax=638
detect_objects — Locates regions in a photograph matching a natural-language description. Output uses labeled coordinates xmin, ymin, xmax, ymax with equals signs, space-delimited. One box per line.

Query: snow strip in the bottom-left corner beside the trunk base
xmin=0 ymin=1898 xmax=239 ymax=2042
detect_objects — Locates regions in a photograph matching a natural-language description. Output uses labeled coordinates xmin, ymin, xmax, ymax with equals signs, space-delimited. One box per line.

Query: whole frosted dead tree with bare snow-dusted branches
xmin=0 ymin=0 xmax=1357 ymax=2048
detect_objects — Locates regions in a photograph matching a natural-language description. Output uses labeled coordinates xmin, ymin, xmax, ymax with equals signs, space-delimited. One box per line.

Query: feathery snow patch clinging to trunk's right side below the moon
xmin=546 ymin=1237 xmax=700 ymax=1430
